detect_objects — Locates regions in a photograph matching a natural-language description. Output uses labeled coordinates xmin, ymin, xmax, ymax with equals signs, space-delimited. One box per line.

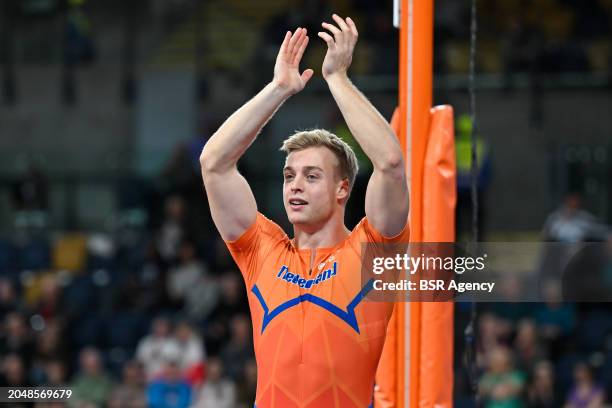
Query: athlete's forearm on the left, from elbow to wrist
xmin=200 ymin=82 xmax=290 ymax=172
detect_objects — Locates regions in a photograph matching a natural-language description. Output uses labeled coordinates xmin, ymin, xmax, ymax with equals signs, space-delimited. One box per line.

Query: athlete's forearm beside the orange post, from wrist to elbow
xmin=326 ymin=73 xmax=403 ymax=170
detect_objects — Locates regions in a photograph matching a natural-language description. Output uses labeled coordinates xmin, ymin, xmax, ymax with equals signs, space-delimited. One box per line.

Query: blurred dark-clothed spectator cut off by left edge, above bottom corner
xmin=0 ymin=312 xmax=34 ymax=370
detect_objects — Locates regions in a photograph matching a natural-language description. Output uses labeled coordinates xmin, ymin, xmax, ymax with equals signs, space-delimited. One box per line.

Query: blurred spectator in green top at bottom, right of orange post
xmin=479 ymin=347 xmax=525 ymax=408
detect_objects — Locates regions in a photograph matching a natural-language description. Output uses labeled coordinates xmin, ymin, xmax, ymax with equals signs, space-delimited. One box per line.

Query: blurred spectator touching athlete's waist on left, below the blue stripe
xmin=220 ymin=315 xmax=253 ymax=381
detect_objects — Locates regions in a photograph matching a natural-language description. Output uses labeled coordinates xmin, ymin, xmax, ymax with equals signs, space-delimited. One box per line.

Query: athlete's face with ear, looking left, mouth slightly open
xmin=283 ymin=147 xmax=348 ymax=228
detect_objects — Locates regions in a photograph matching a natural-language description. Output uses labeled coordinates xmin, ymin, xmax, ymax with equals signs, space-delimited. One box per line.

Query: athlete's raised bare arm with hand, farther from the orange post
xmin=200 ymin=28 xmax=313 ymax=241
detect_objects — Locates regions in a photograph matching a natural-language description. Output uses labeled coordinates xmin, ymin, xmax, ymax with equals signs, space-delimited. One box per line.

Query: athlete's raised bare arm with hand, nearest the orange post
xmin=318 ymin=14 xmax=408 ymax=237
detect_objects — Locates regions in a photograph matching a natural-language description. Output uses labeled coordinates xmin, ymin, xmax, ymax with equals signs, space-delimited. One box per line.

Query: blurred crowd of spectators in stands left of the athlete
xmin=0 ymin=190 xmax=257 ymax=407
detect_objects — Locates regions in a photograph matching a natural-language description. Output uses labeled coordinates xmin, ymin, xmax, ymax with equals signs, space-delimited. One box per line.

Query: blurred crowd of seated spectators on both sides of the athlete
xmin=0 ymin=186 xmax=612 ymax=408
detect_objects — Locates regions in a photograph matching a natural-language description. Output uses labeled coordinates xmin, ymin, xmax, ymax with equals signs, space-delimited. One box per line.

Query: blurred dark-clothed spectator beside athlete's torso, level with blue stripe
xmin=206 ymin=271 xmax=249 ymax=356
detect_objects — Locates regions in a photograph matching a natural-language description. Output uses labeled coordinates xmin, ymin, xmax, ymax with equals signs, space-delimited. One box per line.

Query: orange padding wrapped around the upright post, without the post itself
xmin=374 ymin=106 xmax=456 ymax=408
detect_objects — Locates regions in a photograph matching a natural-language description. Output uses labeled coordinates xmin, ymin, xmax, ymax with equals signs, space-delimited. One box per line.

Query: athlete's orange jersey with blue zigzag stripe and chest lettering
xmin=227 ymin=213 xmax=409 ymax=408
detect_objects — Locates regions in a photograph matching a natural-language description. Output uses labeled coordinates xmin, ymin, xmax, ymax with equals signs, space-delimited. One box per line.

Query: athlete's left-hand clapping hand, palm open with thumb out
xmin=273 ymin=28 xmax=313 ymax=95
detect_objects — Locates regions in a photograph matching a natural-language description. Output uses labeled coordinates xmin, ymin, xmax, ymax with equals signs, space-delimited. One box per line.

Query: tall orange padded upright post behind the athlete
xmin=374 ymin=0 xmax=456 ymax=408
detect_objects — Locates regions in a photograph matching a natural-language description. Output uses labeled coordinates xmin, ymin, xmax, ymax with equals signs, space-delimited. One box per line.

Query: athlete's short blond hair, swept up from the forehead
xmin=280 ymin=129 xmax=359 ymax=192
